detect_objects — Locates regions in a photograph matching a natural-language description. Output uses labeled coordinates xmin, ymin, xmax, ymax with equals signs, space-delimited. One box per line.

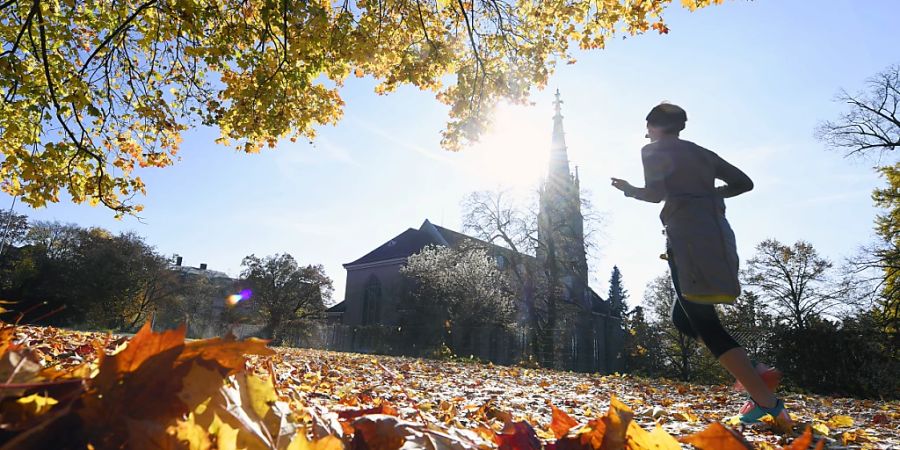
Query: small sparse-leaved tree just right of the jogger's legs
xmin=742 ymin=239 xmax=856 ymax=330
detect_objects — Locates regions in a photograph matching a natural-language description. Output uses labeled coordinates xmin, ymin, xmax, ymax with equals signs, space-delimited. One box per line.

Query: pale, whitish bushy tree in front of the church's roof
xmin=401 ymin=246 xmax=516 ymax=350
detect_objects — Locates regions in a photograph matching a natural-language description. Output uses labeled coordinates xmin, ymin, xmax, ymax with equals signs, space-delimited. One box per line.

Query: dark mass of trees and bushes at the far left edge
xmin=0 ymin=221 xmax=175 ymax=330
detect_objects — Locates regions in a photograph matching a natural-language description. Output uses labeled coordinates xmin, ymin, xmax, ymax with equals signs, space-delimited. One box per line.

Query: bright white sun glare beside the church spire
xmin=465 ymin=104 xmax=553 ymax=189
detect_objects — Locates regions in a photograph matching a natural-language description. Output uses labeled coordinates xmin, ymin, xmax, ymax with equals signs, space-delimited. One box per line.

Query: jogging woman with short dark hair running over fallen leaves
xmin=612 ymin=103 xmax=791 ymax=427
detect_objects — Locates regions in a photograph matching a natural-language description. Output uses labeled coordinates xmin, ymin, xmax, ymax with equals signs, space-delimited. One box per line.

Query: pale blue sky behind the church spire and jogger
xmin=0 ymin=0 xmax=900 ymax=305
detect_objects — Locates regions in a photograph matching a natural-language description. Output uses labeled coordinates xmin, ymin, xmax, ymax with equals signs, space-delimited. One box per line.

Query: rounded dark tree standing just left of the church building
xmin=241 ymin=253 xmax=334 ymax=344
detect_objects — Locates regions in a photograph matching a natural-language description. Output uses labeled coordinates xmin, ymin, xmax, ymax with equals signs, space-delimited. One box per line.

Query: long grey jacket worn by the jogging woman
xmin=625 ymin=138 xmax=753 ymax=303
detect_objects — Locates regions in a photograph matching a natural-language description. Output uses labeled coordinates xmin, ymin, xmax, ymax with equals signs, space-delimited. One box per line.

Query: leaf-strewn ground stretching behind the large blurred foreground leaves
xmin=0 ymin=327 xmax=900 ymax=450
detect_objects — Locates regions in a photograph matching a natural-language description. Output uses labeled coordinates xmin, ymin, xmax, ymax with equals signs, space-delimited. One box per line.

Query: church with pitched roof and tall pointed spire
xmin=327 ymin=91 xmax=624 ymax=373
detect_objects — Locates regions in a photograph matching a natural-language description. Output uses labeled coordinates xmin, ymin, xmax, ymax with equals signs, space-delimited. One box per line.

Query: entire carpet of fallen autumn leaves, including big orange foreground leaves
xmin=0 ymin=326 xmax=900 ymax=450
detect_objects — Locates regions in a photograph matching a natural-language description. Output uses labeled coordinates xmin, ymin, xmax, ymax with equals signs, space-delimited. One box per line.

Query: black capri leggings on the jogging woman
xmin=668 ymin=249 xmax=741 ymax=359
